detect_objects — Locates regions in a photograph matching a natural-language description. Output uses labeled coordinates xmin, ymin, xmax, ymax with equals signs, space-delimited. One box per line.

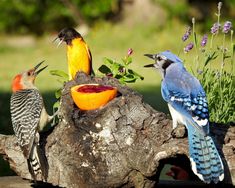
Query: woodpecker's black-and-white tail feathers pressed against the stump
xmin=27 ymin=145 xmax=48 ymax=181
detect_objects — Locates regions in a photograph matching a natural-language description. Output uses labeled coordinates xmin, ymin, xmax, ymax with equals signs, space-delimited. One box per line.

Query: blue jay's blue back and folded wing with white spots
xmin=162 ymin=69 xmax=209 ymax=134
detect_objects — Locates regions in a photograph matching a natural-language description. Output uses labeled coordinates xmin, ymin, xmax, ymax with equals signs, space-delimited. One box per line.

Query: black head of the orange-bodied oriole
xmin=58 ymin=28 xmax=82 ymax=45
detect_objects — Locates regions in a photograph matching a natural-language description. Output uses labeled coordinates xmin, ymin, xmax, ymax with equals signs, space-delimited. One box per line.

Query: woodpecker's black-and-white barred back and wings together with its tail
xmin=11 ymin=89 xmax=47 ymax=180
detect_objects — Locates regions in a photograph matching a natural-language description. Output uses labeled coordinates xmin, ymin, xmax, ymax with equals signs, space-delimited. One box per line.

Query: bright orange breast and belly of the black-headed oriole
xmin=67 ymin=38 xmax=91 ymax=79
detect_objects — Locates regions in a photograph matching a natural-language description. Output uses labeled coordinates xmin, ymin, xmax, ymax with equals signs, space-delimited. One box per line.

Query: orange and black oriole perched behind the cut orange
xmin=58 ymin=28 xmax=94 ymax=80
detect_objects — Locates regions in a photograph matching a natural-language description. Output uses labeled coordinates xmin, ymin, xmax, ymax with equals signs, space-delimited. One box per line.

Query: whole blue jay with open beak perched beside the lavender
xmin=145 ymin=51 xmax=224 ymax=183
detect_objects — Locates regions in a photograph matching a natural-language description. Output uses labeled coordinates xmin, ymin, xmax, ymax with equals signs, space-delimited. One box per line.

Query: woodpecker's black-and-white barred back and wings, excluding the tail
xmin=11 ymin=89 xmax=43 ymax=159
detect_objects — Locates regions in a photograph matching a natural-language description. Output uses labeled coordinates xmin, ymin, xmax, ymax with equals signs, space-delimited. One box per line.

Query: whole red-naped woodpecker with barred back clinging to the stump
xmin=10 ymin=62 xmax=53 ymax=180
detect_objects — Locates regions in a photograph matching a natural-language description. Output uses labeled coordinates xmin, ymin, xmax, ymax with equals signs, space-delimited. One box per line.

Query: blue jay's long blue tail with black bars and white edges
xmin=188 ymin=126 xmax=224 ymax=183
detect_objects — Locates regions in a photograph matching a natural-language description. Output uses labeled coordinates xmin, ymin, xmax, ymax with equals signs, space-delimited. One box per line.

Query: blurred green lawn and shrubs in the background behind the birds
xmin=0 ymin=0 xmax=235 ymax=175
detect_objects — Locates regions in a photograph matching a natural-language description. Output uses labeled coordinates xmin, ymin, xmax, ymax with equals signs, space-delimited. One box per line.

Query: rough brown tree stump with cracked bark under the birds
xmin=0 ymin=73 xmax=235 ymax=188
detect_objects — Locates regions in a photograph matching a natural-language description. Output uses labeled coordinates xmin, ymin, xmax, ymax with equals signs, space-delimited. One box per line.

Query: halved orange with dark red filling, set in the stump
xmin=71 ymin=84 xmax=117 ymax=110
